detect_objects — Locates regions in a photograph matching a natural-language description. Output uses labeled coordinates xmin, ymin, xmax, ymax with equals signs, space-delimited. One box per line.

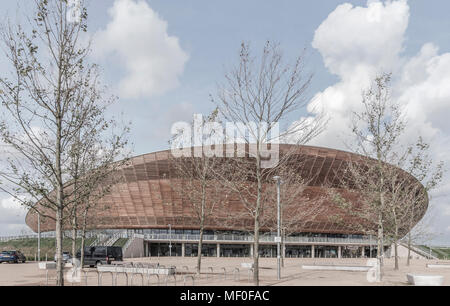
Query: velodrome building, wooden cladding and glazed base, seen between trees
xmin=26 ymin=145 xmax=428 ymax=258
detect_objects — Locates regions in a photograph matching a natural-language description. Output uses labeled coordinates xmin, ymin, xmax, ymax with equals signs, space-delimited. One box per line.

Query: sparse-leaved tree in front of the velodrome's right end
xmin=334 ymin=74 xmax=442 ymax=281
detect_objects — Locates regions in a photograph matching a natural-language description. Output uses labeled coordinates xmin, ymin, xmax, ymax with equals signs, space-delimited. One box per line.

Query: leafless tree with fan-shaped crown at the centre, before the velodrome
xmin=213 ymin=42 xmax=323 ymax=285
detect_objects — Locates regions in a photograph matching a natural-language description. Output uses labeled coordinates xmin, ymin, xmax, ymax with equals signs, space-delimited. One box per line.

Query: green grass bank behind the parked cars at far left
xmin=0 ymin=238 xmax=95 ymax=260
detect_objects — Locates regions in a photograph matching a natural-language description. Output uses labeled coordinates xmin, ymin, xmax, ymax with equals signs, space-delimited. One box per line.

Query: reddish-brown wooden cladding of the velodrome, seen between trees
xmin=26 ymin=145 xmax=428 ymax=233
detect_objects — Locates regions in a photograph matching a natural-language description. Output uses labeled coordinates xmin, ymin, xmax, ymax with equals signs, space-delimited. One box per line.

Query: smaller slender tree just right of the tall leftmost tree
xmin=64 ymin=117 xmax=129 ymax=264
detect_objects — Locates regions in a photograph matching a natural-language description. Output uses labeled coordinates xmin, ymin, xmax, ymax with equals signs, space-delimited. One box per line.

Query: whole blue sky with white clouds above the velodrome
xmin=0 ymin=0 xmax=450 ymax=245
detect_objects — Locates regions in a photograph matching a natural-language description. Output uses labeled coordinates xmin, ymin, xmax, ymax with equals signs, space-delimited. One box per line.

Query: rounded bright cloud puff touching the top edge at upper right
xmin=312 ymin=1 xmax=409 ymax=80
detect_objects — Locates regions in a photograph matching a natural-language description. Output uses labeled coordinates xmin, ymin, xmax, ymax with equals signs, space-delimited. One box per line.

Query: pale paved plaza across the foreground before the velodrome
xmin=0 ymin=257 xmax=450 ymax=286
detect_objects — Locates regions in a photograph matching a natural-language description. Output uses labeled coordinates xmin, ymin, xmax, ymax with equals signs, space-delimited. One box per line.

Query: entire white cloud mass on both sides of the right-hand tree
xmin=309 ymin=0 xmax=450 ymax=244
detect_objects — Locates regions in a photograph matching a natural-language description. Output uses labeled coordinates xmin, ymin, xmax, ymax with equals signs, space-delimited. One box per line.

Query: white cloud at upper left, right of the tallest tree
xmin=94 ymin=0 xmax=188 ymax=98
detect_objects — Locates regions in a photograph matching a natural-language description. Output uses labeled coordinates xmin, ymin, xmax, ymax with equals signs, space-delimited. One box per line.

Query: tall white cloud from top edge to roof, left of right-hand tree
xmin=308 ymin=1 xmax=409 ymax=148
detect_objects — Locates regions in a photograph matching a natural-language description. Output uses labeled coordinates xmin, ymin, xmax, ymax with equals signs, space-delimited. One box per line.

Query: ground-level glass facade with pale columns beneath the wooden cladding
xmin=129 ymin=228 xmax=377 ymax=258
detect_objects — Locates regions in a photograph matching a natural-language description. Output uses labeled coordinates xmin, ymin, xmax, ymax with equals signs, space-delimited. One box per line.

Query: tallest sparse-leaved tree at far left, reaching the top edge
xmin=0 ymin=0 xmax=126 ymax=286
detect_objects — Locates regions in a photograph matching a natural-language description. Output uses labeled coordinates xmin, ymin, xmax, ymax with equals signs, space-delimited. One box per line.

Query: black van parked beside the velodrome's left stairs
xmin=76 ymin=246 xmax=123 ymax=267
